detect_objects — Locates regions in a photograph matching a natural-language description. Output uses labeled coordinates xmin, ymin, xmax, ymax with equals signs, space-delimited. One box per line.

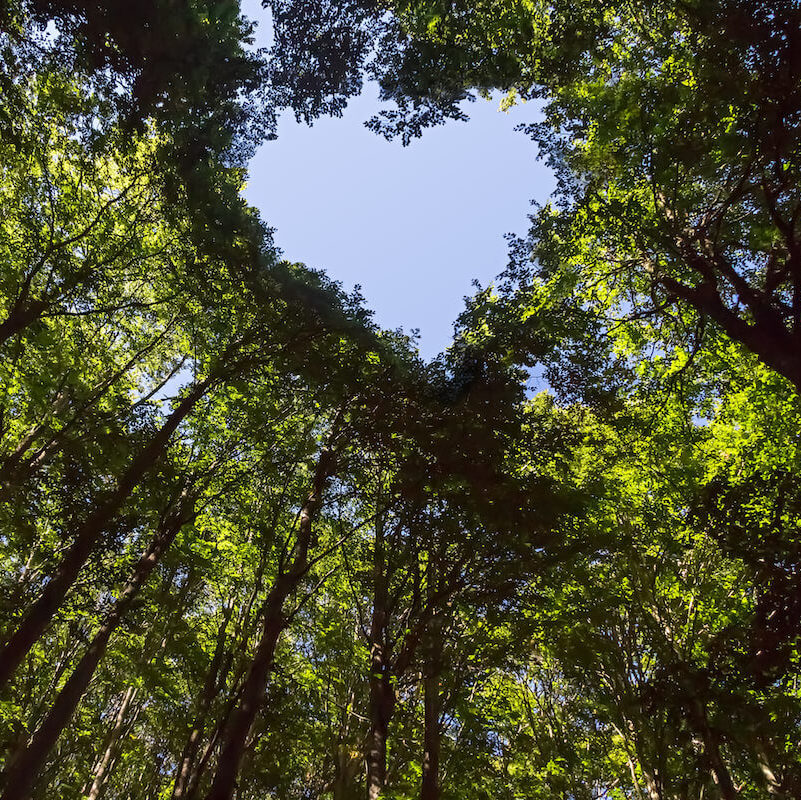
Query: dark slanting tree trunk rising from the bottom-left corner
xmin=0 ymin=496 xmax=194 ymax=800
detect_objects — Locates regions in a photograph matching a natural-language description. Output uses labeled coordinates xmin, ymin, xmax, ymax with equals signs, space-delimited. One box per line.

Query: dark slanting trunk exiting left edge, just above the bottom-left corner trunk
xmin=0 ymin=377 xmax=215 ymax=689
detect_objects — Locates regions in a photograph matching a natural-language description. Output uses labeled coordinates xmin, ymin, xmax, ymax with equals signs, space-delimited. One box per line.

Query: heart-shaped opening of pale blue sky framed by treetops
xmin=243 ymin=2 xmax=553 ymax=358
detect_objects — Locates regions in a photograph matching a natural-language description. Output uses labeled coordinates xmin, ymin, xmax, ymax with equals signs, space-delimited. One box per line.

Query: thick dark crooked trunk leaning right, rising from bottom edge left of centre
xmin=206 ymin=449 xmax=334 ymax=800
